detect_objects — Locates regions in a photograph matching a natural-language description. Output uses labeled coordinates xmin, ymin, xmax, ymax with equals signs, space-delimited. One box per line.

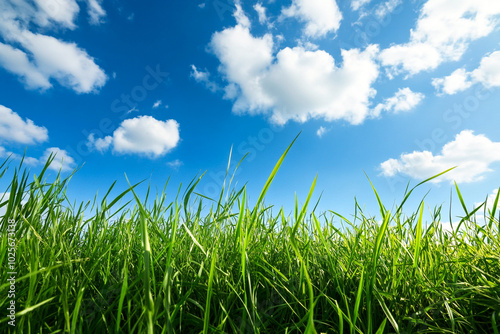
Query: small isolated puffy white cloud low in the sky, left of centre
xmin=88 ymin=116 xmax=180 ymax=158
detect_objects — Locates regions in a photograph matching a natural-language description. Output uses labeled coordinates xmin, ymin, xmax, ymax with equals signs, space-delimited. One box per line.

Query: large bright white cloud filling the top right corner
xmin=380 ymin=0 xmax=500 ymax=75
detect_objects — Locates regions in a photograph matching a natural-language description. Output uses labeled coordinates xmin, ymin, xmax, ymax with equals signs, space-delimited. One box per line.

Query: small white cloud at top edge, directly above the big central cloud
xmin=281 ymin=0 xmax=342 ymax=38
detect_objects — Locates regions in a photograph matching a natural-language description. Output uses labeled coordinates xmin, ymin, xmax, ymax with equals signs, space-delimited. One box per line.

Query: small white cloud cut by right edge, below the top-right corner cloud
xmin=432 ymin=51 xmax=500 ymax=95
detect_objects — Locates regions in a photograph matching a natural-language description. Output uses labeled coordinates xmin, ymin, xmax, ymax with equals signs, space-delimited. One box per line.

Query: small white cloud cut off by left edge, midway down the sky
xmin=0 ymin=105 xmax=49 ymax=144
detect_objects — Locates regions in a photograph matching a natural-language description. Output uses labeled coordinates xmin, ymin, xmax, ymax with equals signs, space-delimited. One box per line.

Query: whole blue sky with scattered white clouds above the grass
xmin=0 ymin=0 xmax=500 ymax=222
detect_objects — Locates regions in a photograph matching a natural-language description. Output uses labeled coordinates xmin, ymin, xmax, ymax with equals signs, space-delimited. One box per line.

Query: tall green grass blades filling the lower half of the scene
xmin=0 ymin=147 xmax=500 ymax=333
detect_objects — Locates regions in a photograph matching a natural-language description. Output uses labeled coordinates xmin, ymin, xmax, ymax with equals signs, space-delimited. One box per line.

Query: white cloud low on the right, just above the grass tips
xmin=380 ymin=130 xmax=500 ymax=183
